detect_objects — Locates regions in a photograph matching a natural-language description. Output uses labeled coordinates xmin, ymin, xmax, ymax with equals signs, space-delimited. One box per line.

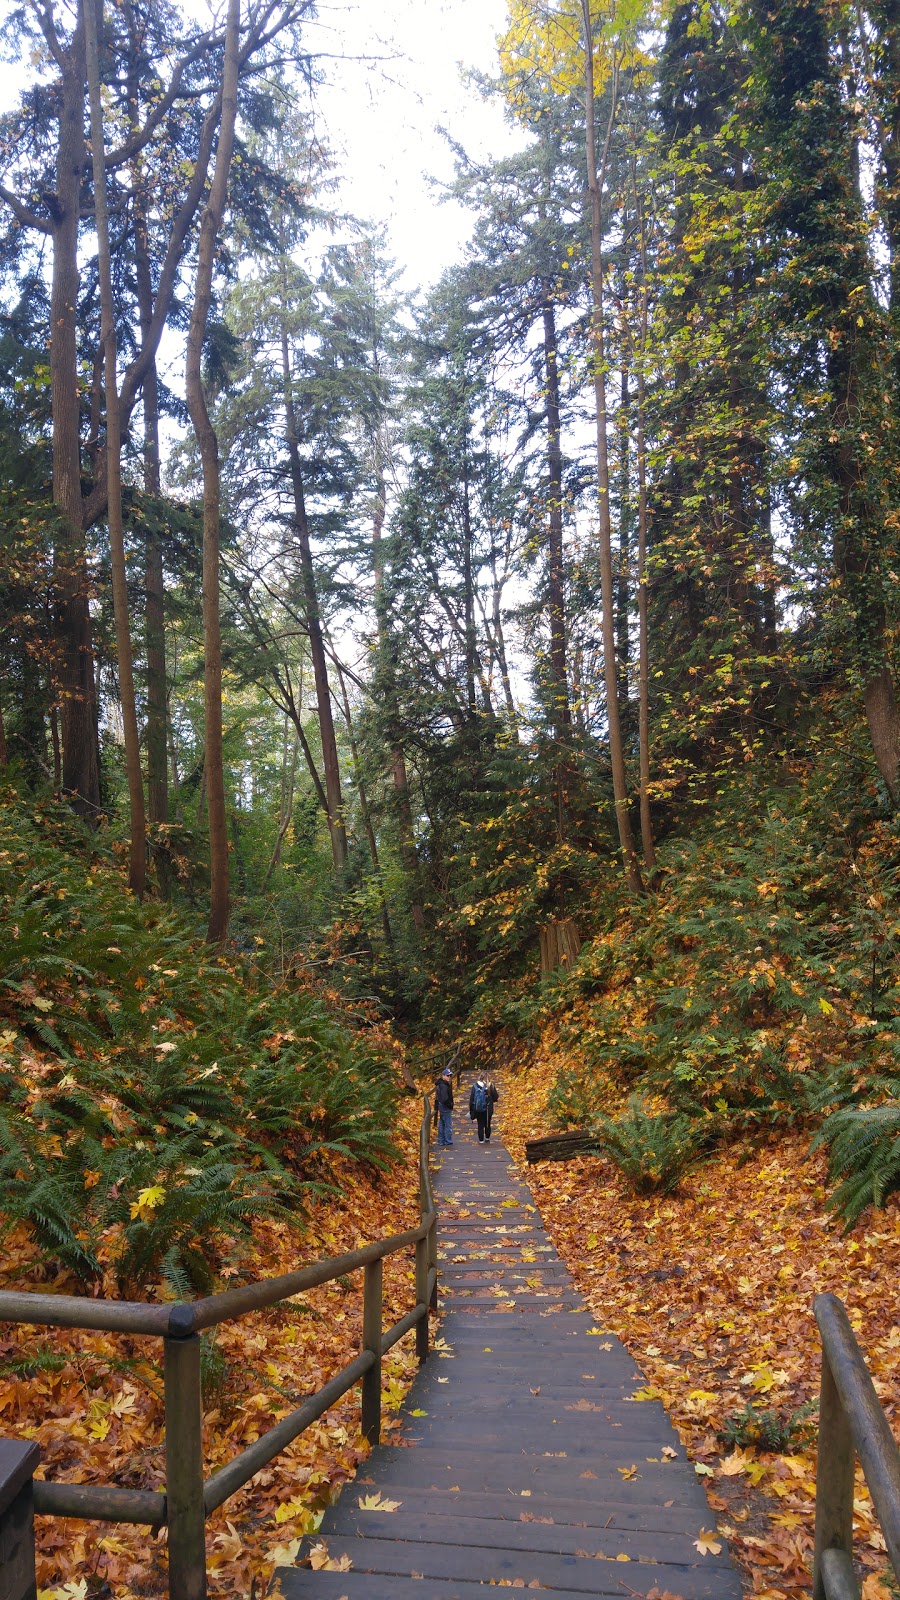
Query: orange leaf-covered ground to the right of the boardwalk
xmin=503 ymin=1054 xmax=900 ymax=1600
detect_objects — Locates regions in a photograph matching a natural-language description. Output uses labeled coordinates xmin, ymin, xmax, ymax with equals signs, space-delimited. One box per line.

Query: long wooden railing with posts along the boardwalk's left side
xmin=0 ymin=1098 xmax=437 ymax=1600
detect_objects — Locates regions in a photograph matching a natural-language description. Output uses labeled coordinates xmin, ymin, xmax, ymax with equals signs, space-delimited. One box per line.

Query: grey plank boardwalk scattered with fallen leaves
xmin=279 ymin=1112 xmax=743 ymax=1600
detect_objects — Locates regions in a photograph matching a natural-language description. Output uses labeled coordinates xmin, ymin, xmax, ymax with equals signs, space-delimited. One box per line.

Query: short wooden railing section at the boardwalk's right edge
xmin=812 ymin=1294 xmax=900 ymax=1600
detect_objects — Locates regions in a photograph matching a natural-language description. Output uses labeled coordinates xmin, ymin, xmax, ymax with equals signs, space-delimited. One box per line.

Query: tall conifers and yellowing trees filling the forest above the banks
xmin=0 ymin=0 xmax=900 ymax=1158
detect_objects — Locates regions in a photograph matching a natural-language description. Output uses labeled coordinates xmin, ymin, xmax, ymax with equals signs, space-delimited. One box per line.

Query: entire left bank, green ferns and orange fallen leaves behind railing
xmin=0 ymin=787 xmax=432 ymax=1600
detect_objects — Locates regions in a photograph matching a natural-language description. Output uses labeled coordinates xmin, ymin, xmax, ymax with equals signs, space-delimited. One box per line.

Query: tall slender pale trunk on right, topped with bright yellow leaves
xmin=581 ymin=0 xmax=644 ymax=891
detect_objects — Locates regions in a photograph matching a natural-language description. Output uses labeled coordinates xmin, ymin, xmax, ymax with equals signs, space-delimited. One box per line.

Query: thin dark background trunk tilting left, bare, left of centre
xmin=282 ymin=325 xmax=348 ymax=872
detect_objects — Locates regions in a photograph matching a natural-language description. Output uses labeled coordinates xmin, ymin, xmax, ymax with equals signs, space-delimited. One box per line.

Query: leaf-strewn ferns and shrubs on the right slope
xmin=482 ymin=763 xmax=900 ymax=1224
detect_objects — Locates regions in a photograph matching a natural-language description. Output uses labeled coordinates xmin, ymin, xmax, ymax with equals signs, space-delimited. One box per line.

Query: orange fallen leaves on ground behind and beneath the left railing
xmin=0 ymin=1099 xmax=421 ymax=1600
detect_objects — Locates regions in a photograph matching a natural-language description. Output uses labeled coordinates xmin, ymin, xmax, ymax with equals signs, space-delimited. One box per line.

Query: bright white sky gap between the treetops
xmin=309 ymin=0 xmax=522 ymax=290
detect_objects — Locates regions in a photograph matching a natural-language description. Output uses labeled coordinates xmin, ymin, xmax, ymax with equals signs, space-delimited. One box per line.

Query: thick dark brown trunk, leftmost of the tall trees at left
xmin=50 ymin=11 xmax=99 ymax=822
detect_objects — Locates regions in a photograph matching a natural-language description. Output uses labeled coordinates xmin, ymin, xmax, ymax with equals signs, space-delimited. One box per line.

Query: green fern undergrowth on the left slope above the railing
xmin=0 ymin=790 xmax=396 ymax=1294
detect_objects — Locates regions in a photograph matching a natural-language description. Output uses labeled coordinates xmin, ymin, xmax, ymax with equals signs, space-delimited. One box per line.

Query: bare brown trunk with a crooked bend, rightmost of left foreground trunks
xmin=186 ymin=0 xmax=240 ymax=944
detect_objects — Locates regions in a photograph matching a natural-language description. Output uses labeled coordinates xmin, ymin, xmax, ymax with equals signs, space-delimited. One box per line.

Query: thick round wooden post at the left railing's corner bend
xmin=163 ymin=1333 xmax=207 ymax=1600
